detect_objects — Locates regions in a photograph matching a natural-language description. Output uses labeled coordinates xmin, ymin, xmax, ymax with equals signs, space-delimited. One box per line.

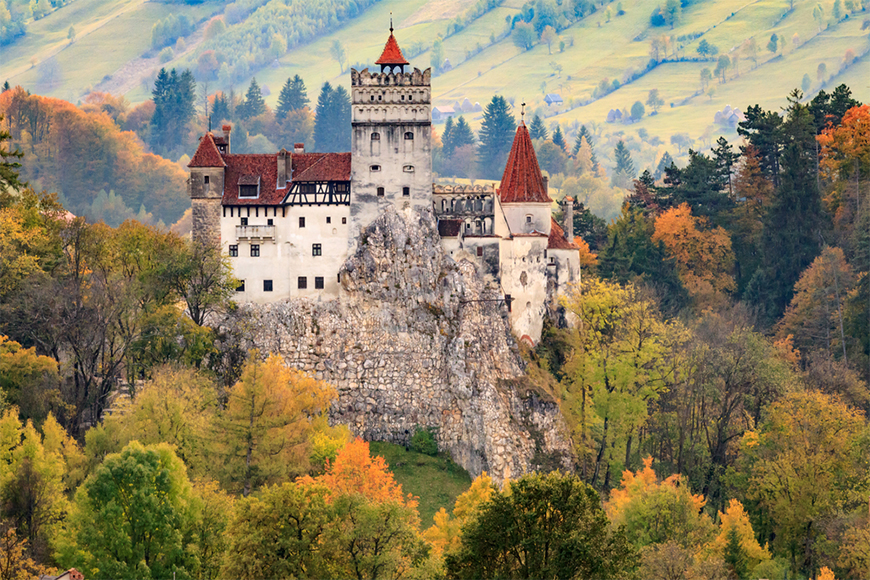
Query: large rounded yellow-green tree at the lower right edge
xmin=741 ymin=390 xmax=870 ymax=574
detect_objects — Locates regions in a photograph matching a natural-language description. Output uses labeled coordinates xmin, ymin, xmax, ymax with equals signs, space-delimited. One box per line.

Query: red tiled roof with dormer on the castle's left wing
xmin=221 ymin=153 xmax=350 ymax=205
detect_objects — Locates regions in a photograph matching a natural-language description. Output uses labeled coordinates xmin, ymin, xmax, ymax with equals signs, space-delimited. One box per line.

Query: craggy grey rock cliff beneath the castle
xmin=228 ymin=209 xmax=572 ymax=481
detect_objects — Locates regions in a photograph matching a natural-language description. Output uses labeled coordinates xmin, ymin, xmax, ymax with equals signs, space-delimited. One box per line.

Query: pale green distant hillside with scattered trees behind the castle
xmin=0 ymin=0 xmax=870 ymax=173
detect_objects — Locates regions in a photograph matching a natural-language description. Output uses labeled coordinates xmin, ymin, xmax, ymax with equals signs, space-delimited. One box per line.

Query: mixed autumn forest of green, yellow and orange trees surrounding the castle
xmin=0 ymin=70 xmax=870 ymax=580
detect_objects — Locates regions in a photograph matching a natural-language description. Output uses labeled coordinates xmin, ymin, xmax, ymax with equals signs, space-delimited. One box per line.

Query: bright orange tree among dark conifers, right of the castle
xmin=653 ymin=204 xmax=734 ymax=302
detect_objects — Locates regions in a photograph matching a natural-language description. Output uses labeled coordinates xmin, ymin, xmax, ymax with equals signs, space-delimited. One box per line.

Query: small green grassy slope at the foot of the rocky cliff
xmin=371 ymin=442 xmax=471 ymax=529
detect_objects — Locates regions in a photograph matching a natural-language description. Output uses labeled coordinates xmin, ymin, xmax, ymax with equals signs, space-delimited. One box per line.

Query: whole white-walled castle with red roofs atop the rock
xmin=188 ymin=27 xmax=580 ymax=344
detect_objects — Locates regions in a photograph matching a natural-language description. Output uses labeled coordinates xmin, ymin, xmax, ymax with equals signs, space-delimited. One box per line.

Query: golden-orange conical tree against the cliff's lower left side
xmin=216 ymin=351 xmax=335 ymax=497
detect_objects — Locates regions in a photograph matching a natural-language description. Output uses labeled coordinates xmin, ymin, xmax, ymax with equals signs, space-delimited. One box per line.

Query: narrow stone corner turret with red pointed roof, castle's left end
xmin=187 ymin=126 xmax=230 ymax=245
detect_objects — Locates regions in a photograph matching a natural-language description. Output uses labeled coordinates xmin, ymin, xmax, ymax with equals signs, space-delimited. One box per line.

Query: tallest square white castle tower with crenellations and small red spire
xmin=350 ymin=23 xmax=432 ymax=239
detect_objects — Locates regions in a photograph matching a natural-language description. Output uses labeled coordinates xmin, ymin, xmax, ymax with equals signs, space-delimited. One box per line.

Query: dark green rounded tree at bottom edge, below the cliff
xmin=445 ymin=472 xmax=637 ymax=579
